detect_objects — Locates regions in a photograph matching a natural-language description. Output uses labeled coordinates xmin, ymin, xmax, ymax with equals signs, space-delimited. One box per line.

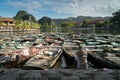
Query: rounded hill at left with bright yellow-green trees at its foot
xmin=14 ymin=11 xmax=40 ymax=29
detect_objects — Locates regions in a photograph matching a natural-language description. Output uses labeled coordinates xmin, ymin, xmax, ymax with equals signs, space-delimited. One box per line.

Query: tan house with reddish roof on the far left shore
xmin=0 ymin=17 xmax=14 ymax=27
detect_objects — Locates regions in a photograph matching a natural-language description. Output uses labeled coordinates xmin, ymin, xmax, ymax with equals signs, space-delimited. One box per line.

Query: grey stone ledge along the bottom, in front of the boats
xmin=0 ymin=69 xmax=120 ymax=80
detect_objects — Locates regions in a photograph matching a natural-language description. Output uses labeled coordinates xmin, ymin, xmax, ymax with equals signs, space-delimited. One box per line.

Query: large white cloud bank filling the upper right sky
xmin=41 ymin=0 xmax=120 ymax=16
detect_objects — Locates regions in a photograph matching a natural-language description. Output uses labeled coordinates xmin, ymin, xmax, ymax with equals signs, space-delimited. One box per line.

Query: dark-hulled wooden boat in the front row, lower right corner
xmin=88 ymin=52 xmax=120 ymax=69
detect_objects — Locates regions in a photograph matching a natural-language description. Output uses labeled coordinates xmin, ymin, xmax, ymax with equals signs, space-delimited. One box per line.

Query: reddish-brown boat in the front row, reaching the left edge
xmin=0 ymin=40 xmax=48 ymax=68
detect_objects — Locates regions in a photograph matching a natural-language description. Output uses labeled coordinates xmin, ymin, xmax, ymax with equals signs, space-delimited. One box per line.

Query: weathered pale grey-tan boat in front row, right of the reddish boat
xmin=23 ymin=43 xmax=62 ymax=69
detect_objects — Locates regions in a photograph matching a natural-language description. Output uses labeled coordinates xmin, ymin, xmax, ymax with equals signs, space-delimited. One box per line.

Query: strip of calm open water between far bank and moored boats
xmin=0 ymin=27 xmax=120 ymax=36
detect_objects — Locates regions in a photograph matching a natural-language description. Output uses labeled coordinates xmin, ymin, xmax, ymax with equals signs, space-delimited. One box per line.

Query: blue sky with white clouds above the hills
xmin=0 ymin=0 xmax=120 ymax=19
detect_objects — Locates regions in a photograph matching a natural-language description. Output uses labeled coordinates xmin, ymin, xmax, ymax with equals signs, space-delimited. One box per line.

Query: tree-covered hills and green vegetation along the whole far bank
xmin=0 ymin=10 xmax=120 ymax=29
